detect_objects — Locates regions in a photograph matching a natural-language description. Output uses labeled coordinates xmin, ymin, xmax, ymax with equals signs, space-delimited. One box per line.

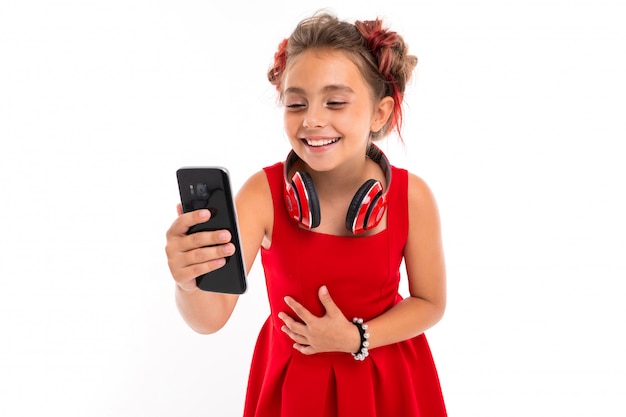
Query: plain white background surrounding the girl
xmin=0 ymin=0 xmax=626 ymax=417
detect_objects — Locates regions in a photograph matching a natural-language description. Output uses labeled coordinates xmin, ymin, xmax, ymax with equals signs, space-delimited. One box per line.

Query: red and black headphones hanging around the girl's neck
xmin=284 ymin=144 xmax=391 ymax=234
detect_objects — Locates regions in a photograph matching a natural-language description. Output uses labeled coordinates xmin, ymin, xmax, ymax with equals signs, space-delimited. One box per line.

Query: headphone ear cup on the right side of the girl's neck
xmin=346 ymin=179 xmax=383 ymax=234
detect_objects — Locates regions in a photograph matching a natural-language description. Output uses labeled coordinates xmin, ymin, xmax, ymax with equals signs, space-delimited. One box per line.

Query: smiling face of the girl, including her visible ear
xmin=283 ymin=50 xmax=393 ymax=171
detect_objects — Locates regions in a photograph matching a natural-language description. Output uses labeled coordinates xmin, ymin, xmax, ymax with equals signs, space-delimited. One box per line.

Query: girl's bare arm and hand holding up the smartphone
xmin=165 ymin=172 xmax=273 ymax=334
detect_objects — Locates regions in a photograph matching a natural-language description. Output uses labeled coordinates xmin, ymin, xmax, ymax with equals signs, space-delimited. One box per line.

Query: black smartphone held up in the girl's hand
xmin=176 ymin=167 xmax=247 ymax=294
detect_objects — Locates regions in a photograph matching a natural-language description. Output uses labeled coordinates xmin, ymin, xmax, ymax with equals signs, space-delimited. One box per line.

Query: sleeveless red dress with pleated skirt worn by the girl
xmin=244 ymin=163 xmax=446 ymax=417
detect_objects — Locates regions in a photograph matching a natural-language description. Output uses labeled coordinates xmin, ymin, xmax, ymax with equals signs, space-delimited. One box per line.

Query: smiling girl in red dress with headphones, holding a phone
xmin=166 ymin=14 xmax=446 ymax=417
